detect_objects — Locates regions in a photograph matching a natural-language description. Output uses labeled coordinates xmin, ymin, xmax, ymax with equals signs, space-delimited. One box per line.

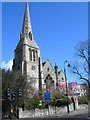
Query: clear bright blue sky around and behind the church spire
xmin=2 ymin=2 xmax=88 ymax=81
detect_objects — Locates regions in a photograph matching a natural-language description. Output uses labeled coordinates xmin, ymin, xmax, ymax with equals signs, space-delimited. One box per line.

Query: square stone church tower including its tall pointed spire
xmin=12 ymin=2 xmax=41 ymax=90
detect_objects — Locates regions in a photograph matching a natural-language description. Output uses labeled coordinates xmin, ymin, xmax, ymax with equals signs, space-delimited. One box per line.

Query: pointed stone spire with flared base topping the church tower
xmin=16 ymin=2 xmax=39 ymax=49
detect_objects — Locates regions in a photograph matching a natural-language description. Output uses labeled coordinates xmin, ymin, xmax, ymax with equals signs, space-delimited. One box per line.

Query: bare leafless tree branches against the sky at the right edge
xmin=71 ymin=41 xmax=90 ymax=83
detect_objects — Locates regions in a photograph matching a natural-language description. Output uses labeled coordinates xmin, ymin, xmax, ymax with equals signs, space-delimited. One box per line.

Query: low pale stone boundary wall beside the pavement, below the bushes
xmin=19 ymin=104 xmax=88 ymax=118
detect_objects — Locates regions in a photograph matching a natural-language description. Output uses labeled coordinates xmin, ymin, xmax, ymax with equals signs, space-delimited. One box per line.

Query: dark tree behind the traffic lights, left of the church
xmin=2 ymin=69 xmax=27 ymax=113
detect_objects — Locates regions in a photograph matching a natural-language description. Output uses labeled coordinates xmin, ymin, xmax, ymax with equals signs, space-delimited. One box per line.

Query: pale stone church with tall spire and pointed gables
xmin=12 ymin=2 xmax=65 ymax=95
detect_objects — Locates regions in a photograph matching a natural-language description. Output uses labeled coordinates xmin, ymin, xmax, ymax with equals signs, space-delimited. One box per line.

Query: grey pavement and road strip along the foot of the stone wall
xmin=3 ymin=109 xmax=90 ymax=120
